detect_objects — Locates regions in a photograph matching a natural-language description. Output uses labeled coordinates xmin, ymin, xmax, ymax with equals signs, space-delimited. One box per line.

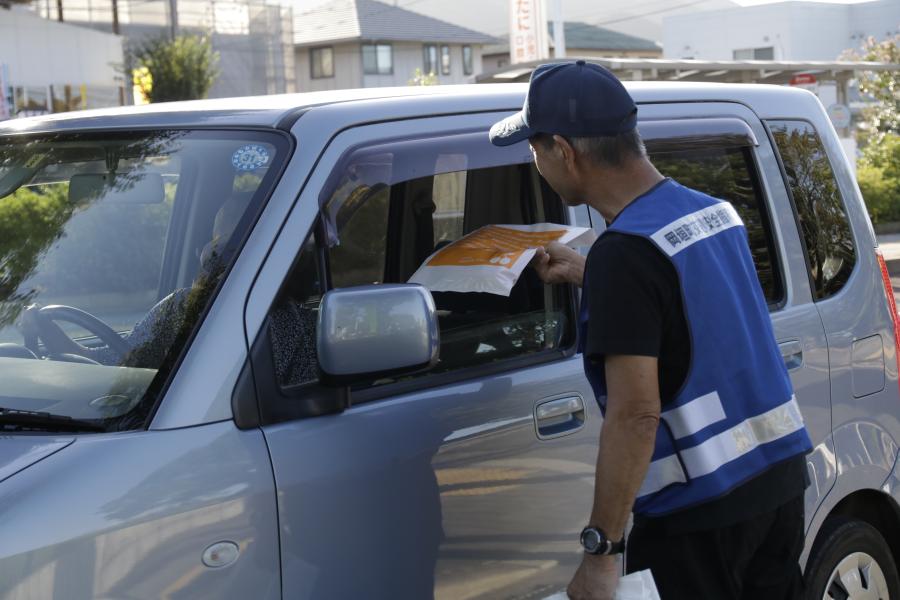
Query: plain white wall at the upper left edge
xmin=0 ymin=9 xmax=124 ymax=89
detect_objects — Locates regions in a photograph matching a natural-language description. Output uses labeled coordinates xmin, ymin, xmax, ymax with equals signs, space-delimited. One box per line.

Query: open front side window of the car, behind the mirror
xmin=269 ymin=134 xmax=574 ymax=387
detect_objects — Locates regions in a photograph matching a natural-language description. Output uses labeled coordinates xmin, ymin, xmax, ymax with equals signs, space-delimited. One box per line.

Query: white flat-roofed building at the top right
xmin=663 ymin=0 xmax=900 ymax=61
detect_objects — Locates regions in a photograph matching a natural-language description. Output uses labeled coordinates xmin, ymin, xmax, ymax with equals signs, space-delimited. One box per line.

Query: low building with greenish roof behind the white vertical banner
xmin=481 ymin=22 xmax=662 ymax=73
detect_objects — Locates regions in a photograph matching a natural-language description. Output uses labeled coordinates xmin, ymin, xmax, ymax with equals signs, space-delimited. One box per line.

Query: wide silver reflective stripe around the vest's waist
xmin=638 ymin=394 xmax=803 ymax=498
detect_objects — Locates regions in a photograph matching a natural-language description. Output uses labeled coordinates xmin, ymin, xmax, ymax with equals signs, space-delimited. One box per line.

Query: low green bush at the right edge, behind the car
xmin=856 ymin=133 xmax=900 ymax=223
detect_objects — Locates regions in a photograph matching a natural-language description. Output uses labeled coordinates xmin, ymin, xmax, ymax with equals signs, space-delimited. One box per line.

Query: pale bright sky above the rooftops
xmin=294 ymin=0 xmax=880 ymax=42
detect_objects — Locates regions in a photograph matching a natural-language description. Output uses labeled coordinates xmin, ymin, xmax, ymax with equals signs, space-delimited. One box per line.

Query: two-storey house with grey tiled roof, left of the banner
xmin=294 ymin=0 xmax=497 ymax=92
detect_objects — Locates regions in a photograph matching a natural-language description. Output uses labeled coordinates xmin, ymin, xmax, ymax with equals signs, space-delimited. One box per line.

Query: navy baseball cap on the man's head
xmin=490 ymin=60 xmax=637 ymax=146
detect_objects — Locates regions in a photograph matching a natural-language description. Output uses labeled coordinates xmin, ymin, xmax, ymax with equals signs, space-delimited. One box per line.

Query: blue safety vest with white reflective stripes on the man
xmin=579 ymin=179 xmax=812 ymax=516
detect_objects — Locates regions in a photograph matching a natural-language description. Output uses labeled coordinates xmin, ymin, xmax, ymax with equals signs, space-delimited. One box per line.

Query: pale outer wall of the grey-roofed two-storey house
xmin=295 ymin=42 xmax=481 ymax=92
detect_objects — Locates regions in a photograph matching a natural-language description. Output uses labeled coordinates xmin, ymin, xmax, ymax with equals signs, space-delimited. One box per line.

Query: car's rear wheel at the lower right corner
xmin=804 ymin=518 xmax=900 ymax=600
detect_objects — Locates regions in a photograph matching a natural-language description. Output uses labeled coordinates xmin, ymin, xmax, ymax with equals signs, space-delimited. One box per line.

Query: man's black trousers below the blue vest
xmin=626 ymin=495 xmax=804 ymax=600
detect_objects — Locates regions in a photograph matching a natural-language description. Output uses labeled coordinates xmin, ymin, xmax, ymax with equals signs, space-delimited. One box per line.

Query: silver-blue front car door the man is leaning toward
xmin=243 ymin=113 xmax=601 ymax=599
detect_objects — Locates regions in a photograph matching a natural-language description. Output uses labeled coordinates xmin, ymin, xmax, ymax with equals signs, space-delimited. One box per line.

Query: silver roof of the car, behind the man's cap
xmin=0 ymin=81 xmax=815 ymax=134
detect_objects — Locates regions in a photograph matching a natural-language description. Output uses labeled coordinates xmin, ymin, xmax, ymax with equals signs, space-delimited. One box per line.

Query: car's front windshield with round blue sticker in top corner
xmin=0 ymin=130 xmax=288 ymax=431
